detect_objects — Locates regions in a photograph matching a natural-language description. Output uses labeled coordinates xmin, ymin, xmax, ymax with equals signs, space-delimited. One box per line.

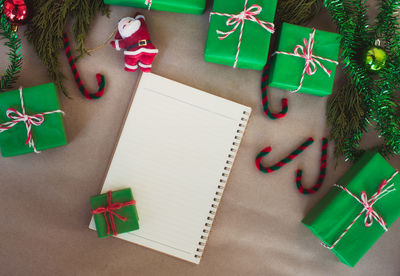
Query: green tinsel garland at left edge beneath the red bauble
xmin=0 ymin=1 xmax=22 ymax=92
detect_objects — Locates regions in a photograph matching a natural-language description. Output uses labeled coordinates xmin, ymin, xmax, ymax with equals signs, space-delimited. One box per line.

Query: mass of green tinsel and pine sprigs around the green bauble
xmin=323 ymin=0 xmax=400 ymax=160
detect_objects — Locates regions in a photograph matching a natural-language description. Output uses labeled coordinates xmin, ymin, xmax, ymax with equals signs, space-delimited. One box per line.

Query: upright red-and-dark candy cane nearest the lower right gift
xmin=296 ymin=138 xmax=328 ymax=195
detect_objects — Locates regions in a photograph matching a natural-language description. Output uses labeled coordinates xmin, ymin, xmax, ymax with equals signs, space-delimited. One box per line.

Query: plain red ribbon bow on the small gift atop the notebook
xmin=90 ymin=191 xmax=136 ymax=236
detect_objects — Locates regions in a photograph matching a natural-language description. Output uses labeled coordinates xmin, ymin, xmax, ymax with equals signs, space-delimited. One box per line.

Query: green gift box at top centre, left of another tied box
xmin=204 ymin=0 xmax=277 ymax=70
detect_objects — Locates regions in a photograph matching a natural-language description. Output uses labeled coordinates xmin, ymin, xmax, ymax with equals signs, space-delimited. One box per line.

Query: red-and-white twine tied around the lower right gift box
xmin=322 ymin=171 xmax=398 ymax=249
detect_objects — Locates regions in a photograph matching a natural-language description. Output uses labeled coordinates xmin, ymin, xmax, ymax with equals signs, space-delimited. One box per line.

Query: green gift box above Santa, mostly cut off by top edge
xmin=104 ymin=0 xmax=206 ymax=14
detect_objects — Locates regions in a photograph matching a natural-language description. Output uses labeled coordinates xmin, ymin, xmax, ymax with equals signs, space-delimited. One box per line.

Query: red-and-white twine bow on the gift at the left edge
xmin=0 ymin=87 xmax=64 ymax=153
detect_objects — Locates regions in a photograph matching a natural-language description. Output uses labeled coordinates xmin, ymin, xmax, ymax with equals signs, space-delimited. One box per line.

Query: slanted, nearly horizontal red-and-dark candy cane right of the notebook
xmin=256 ymin=137 xmax=314 ymax=173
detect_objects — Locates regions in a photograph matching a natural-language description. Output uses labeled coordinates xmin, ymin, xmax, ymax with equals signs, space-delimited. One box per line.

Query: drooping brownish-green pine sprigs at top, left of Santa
xmin=25 ymin=0 xmax=109 ymax=95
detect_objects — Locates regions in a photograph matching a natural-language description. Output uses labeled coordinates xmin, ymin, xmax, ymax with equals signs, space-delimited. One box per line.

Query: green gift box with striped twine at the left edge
xmin=0 ymin=83 xmax=67 ymax=157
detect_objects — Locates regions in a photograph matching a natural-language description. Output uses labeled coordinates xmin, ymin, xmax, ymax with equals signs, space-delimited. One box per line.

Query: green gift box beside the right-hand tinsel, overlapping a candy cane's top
xmin=268 ymin=23 xmax=340 ymax=97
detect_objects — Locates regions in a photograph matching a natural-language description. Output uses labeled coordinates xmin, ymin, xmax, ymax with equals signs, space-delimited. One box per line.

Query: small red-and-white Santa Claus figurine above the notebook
xmin=111 ymin=13 xmax=158 ymax=73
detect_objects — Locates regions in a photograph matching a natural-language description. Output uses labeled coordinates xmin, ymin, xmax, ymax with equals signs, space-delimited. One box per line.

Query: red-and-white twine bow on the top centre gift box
xmin=210 ymin=0 xmax=275 ymax=68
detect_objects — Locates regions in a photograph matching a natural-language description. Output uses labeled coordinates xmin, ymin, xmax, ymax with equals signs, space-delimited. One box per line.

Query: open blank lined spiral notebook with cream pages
xmin=89 ymin=74 xmax=251 ymax=264
